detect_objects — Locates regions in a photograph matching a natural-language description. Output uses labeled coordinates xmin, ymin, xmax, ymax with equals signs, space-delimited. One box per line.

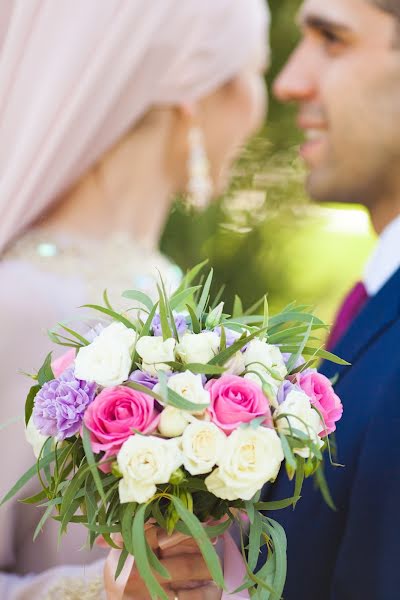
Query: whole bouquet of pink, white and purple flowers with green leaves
xmin=3 ymin=264 xmax=344 ymax=600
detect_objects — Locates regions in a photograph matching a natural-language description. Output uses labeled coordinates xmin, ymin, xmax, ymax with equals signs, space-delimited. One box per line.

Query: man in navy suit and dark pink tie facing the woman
xmin=264 ymin=0 xmax=400 ymax=600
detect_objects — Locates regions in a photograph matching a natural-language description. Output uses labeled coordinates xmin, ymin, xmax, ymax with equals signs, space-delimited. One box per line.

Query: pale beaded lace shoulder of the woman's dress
xmin=1 ymin=228 xmax=182 ymax=310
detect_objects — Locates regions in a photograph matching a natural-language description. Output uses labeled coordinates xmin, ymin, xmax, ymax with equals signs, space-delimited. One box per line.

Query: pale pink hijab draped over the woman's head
xmin=0 ymin=0 xmax=268 ymax=254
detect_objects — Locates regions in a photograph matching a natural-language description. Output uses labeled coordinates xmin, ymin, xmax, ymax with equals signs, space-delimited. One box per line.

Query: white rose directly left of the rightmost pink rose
xmin=274 ymin=390 xmax=324 ymax=458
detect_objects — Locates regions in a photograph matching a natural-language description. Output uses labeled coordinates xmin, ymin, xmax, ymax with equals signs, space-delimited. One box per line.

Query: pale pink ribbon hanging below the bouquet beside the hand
xmin=104 ymin=532 xmax=250 ymax=600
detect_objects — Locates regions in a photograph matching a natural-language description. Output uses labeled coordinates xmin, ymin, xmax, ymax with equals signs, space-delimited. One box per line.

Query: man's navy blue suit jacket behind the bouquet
xmin=264 ymin=270 xmax=400 ymax=600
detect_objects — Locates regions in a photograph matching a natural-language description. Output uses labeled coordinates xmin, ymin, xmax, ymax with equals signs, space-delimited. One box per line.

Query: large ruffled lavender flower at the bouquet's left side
xmin=32 ymin=367 xmax=96 ymax=441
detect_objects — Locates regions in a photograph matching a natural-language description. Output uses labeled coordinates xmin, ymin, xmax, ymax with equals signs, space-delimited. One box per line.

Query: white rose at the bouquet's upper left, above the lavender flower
xmin=75 ymin=323 xmax=136 ymax=387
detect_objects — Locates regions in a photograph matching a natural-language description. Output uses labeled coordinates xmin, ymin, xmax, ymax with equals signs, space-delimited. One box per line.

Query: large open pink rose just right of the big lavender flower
xmin=83 ymin=385 xmax=160 ymax=458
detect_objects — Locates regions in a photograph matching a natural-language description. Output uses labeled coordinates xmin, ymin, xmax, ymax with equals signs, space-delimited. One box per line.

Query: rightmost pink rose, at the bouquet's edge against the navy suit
xmin=297 ymin=371 xmax=343 ymax=437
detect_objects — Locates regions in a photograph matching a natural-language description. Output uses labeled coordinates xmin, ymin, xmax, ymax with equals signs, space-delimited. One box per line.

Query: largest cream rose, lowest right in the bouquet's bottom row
xmin=205 ymin=427 xmax=284 ymax=500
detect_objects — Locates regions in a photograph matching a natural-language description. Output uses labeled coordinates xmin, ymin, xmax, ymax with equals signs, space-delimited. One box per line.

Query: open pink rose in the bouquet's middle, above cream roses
xmin=206 ymin=374 xmax=272 ymax=434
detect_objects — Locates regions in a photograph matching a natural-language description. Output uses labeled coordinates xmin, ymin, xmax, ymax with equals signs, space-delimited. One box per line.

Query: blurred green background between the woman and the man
xmin=162 ymin=0 xmax=374 ymax=328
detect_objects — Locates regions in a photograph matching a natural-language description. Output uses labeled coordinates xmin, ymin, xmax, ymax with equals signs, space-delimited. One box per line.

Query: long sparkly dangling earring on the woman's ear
xmin=187 ymin=126 xmax=213 ymax=210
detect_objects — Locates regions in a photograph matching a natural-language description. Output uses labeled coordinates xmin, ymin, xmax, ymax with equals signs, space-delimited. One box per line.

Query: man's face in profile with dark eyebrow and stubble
xmin=275 ymin=0 xmax=400 ymax=208
